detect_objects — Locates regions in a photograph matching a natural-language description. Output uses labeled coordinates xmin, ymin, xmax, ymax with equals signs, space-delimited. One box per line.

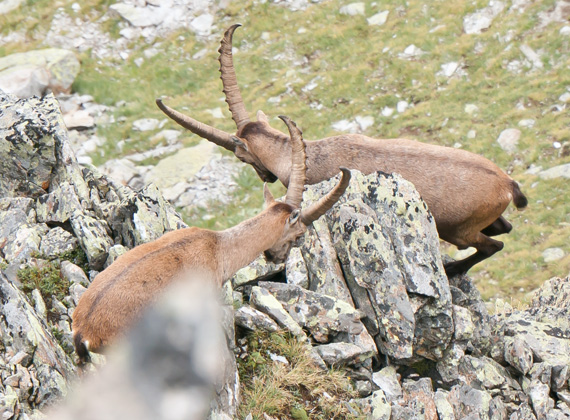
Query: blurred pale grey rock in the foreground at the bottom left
xmin=43 ymin=274 xmax=235 ymax=420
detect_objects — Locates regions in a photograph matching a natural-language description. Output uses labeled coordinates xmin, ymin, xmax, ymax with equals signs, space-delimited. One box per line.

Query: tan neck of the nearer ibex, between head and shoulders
xmin=220 ymin=211 xmax=284 ymax=280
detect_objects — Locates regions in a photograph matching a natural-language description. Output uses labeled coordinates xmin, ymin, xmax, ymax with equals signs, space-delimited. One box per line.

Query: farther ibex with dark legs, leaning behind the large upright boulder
xmin=156 ymin=24 xmax=527 ymax=276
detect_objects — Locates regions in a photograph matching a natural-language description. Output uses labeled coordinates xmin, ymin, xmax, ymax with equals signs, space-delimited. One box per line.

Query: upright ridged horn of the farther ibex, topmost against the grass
xmin=218 ymin=23 xmax=249 ymax=131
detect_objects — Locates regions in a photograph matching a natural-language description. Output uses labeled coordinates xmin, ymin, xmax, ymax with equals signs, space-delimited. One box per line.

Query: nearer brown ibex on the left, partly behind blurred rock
xmin=73 ymin=116 xmax=350 ymax=361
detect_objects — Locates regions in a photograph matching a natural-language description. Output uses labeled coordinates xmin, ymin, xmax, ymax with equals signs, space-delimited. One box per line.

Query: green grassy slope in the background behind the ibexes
xmin=0 ymin=0 xmax=570 ymax=299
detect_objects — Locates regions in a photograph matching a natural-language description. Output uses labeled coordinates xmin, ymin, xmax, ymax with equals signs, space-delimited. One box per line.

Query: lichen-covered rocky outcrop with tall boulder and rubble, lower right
xmin=229 ymin=171 xmax=570 ymax=419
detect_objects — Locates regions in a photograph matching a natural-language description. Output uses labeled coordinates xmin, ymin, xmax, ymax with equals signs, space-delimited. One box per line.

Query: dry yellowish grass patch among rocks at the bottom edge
xmin=237 ymin=332 xmax=356 ymax=420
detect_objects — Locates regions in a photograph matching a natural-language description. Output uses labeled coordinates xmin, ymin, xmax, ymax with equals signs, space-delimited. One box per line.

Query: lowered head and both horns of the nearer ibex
xmin=264 ymin=115 xmax=350 ymax=262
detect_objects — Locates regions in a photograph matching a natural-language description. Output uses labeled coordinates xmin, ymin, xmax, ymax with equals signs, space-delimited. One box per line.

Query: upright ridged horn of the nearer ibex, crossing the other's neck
xmin=279 ymin=115 xmax=307 ymax=208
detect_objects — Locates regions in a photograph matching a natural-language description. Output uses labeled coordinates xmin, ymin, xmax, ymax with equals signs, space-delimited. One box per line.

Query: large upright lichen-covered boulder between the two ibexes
xmin=303 ymin=171 xmax=453 ymax=362
